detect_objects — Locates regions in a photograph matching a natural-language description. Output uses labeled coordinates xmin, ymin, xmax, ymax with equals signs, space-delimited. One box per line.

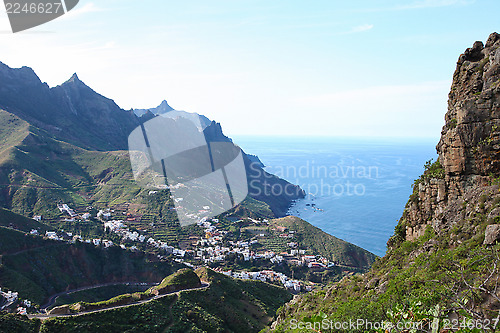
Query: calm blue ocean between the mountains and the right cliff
xmin=233 ymin=136 xmax=438 ymax=256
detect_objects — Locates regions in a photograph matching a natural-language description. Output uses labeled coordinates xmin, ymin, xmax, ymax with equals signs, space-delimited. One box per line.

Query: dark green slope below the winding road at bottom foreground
xmin=31 ymin=268 xmax=291 ymax=333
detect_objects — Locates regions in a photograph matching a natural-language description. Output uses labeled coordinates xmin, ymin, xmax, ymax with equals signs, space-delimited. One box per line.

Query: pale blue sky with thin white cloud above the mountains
xmin=0 ymin=0 xmax=500 ymax=138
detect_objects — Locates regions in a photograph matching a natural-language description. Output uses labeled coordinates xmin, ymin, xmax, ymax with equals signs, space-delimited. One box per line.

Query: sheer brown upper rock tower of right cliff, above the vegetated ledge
xmin=437 ymin=33 xmax=500 ymax=177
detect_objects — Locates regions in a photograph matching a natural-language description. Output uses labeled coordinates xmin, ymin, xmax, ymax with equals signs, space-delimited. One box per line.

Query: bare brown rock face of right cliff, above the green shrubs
xmin=402 ymin=33 xmax=500 ymax=241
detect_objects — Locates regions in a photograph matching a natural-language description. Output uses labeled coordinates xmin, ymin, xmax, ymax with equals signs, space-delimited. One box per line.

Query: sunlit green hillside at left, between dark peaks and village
xmin=0 ymin=110 xmax=147 ymax=218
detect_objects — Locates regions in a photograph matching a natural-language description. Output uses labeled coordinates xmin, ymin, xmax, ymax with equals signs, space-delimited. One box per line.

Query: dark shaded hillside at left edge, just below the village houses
xmin=0 ymin=227 xmax=182 ymax=304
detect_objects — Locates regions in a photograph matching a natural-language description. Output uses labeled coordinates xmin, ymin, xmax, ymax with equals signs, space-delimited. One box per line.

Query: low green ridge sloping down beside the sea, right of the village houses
xmin=271 ymin=216 xmax=376 ymax=268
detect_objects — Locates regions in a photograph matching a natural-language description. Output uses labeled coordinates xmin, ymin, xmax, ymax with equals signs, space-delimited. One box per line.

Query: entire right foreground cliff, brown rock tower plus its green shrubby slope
xmin=273 ymin=33 xmax=500 ymax=332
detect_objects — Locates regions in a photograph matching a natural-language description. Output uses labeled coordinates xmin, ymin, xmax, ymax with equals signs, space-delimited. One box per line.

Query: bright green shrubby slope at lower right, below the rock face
xmin=277 ymin=185 xmax=500 ymax=332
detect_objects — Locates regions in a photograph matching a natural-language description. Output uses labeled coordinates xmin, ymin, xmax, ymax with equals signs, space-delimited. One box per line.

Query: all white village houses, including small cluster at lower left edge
xmin=0 ymin=195 xmax=350 ymax=314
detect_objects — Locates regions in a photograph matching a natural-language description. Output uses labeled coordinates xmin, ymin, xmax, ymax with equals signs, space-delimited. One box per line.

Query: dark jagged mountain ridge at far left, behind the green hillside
xmin=0 ymin=64 xmax=139 ymax=150
